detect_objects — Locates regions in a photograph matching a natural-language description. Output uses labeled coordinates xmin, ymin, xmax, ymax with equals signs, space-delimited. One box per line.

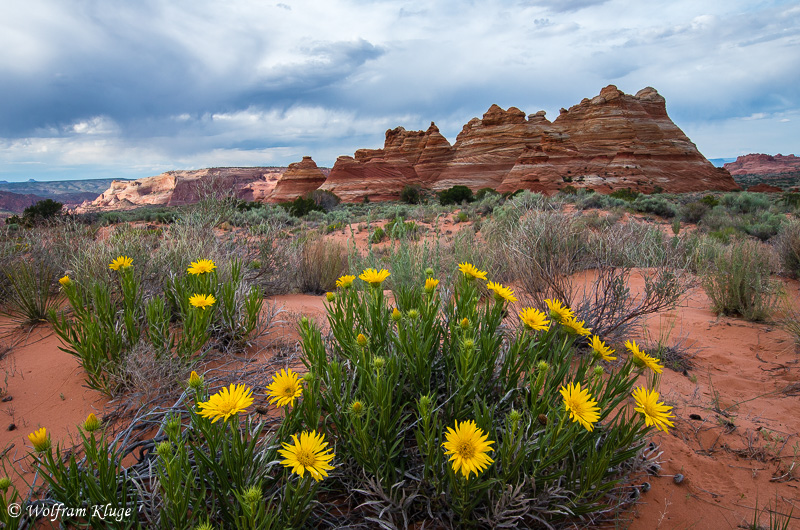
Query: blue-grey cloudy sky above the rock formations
xmin=0 ymin=0 xmax=800 ymax=181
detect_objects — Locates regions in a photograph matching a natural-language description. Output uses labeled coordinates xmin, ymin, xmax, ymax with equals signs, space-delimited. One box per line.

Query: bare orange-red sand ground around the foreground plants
xmin=0 ymin=272 xmax=800 ymax=530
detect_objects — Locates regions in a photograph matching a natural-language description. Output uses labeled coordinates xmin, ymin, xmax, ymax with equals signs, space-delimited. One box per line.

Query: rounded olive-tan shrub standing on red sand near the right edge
xmin=702 ymin=240 xmax=780 ymax=320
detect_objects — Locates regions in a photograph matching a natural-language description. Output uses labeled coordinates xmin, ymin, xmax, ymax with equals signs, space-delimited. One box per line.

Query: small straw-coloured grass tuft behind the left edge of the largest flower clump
xmin=297 ymin=236 xmax=347 ymax=294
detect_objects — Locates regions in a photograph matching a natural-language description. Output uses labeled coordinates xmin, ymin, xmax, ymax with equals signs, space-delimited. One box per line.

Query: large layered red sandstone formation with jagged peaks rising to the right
xmin=322 ymin=85 xmax=738 ymax=201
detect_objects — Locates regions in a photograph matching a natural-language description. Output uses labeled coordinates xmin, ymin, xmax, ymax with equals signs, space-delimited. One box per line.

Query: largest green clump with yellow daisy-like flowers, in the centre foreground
xmin=290 ymin=262 xmax=671 ymax=528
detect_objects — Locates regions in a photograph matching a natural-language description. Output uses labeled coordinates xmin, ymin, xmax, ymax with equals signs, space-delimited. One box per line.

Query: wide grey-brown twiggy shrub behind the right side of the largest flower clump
xmin=490 ymin=211 xmax=692 ymax=338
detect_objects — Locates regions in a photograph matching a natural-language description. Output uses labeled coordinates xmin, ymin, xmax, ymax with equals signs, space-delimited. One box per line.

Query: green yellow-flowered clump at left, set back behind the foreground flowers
xmin=49 ymin=256 xmax=262 ymax=395
